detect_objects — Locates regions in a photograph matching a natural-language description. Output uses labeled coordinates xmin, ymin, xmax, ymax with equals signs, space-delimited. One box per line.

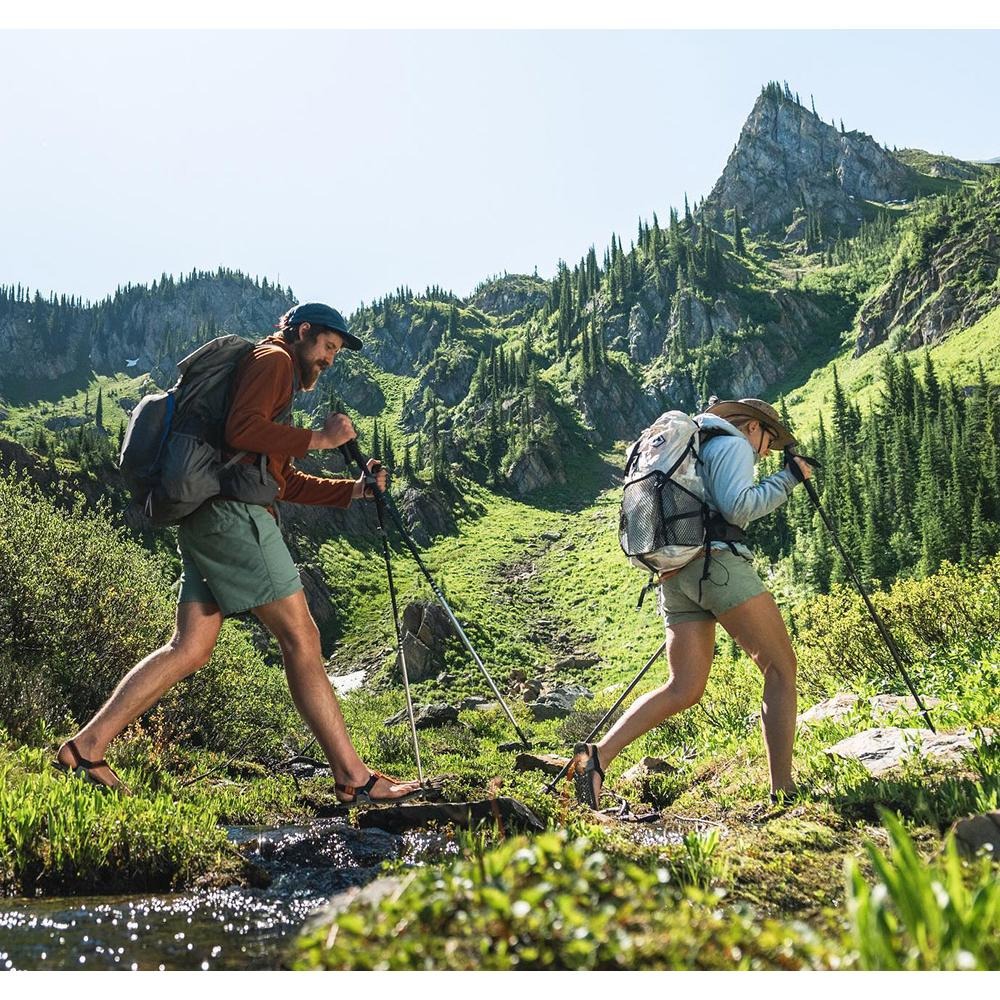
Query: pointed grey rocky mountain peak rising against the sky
xmin=704 ymin=84 xmax=914 ymax=235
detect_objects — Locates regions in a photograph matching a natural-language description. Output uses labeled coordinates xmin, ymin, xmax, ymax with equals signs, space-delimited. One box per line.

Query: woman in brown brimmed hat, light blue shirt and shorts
xmin=570 ymin=399 xmax=811 ymax=809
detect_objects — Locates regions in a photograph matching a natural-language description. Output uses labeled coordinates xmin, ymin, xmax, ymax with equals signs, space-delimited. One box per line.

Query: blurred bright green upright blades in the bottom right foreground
xmin=847 ymin=811 xmax=1000 ymax=970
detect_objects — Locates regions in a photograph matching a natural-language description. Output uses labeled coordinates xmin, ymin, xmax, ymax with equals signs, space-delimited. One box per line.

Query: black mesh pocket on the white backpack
xmin=618 ymin=470 xmax=705 ymax=556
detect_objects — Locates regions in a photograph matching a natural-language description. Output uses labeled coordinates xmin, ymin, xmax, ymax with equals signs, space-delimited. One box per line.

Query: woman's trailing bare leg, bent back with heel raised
xmin=580 ymin=621 xmax=715 ymax=795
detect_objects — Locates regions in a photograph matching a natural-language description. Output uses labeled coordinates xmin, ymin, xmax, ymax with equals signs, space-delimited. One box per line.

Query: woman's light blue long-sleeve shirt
xmin=699 ymin=414 xmax=798 ymax=559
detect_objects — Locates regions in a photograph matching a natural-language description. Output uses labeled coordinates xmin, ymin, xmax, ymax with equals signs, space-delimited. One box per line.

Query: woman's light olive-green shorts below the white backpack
xmin=658 ymin=548 xmax=767 ymax=628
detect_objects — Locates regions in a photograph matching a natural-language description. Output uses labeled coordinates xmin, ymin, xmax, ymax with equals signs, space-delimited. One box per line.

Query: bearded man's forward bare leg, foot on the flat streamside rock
xmin=254 ymin=590 xmax=419 ymax=799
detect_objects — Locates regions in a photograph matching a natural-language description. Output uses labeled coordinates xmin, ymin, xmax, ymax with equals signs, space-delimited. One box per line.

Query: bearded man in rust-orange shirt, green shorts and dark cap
xmin=55 ymin=302 xmax=419 ymax=803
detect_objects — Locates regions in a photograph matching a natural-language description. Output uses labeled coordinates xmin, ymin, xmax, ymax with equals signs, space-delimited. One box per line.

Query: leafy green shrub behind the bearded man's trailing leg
xmin=0 ymin=475 xmax=294 ymax=755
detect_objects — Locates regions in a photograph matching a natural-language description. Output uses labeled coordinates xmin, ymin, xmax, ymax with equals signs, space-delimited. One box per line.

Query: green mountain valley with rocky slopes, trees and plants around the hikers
xmin=0 ymin=82 xmax=1000 ymax=968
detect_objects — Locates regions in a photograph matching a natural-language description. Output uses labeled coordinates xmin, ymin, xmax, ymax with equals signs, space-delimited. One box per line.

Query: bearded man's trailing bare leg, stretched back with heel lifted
xmin=57 ymin=603 xmax=222 ymax=787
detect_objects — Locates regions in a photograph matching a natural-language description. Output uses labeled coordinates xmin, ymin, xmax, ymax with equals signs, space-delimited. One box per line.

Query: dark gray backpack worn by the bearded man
xmin=118 ymin=334 xmax=294 ymax=525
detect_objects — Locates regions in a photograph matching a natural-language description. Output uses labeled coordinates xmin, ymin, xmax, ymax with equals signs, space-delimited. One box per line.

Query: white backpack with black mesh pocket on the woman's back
xmin=619 ymin=410 xmax=711 ymax=573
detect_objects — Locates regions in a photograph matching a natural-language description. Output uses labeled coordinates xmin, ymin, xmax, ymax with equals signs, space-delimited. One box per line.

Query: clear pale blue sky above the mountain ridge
xmin=0 ymin=30 xmax=1000 ymax=312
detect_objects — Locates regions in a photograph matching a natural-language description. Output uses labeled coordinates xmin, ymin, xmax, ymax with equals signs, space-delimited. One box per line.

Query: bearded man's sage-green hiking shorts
xmin=177 ymin=500 xmax=302 ymax=617
